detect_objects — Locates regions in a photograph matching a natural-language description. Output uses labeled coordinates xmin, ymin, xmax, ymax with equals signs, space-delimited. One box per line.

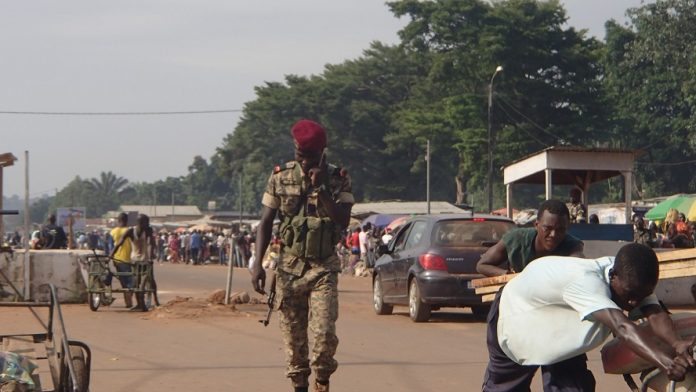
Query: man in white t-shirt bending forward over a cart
xmin=483 ymin=243 xmax=696 ymax=392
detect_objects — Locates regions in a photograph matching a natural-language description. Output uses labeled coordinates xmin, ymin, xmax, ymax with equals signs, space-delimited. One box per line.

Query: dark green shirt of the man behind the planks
xmin=502 ymin=227 xmax=582 ymax=272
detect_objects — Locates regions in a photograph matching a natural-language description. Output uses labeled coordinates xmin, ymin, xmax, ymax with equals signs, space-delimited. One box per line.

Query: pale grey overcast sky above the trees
xmin=0 ymin=0 xmax=641 ymax=197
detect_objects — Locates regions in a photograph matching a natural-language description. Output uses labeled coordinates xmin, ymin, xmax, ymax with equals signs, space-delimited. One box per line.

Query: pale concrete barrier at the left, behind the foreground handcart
xmin=0 ymin=249 xmax=92 ymax=303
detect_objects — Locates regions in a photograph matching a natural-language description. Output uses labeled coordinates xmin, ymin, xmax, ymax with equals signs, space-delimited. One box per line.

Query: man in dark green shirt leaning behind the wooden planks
xmin=476 ymin=199 xmax=585 ymax=276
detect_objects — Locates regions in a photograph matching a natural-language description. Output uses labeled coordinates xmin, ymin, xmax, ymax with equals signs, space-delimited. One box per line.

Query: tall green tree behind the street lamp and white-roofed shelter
xmin=389 ymin=0 xmax=603 ymax=206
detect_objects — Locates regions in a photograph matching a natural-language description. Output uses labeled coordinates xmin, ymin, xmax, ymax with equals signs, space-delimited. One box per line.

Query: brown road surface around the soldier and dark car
xmin=0 ymin=264 xmax=628 ymax=392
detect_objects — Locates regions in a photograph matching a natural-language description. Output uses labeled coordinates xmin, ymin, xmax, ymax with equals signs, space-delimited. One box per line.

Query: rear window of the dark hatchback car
xmin=433 ymin=219 xmax=515 ymax=246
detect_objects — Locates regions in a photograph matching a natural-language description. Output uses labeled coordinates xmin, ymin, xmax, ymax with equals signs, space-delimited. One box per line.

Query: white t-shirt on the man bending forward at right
xmin=498 ymin=256 xmax=658 ymax=365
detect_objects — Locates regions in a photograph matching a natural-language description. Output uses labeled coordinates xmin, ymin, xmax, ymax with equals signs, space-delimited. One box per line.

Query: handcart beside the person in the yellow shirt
xmin=87 ymin=250 xmax=159 ymax=312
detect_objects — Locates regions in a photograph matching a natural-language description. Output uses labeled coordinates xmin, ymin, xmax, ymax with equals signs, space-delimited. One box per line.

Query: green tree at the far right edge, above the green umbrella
xmin=604 ymin=0 xmax=696 ymax=197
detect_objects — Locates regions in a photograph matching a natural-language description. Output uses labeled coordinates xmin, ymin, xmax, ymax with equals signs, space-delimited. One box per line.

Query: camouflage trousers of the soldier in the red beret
xmin=277 ymin=268 xmax=338 ymax=387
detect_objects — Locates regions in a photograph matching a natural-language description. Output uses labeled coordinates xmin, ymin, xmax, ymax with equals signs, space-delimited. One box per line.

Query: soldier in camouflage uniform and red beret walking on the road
xmin=252 ymin=120 xmax=354 ymax=392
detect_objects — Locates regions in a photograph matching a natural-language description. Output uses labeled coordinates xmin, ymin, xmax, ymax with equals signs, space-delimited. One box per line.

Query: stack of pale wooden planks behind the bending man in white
xmin=471 ymin=248 xmax=696 ymax=303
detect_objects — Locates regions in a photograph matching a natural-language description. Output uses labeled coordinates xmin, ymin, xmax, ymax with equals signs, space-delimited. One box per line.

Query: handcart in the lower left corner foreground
xmin=0 ymin=284 xmax=92 ymax=392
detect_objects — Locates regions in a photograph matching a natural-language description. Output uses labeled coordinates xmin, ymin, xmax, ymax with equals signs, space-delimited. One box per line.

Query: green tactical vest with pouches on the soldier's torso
xmin=280 ymin=164 xmax=341 ymax=260
